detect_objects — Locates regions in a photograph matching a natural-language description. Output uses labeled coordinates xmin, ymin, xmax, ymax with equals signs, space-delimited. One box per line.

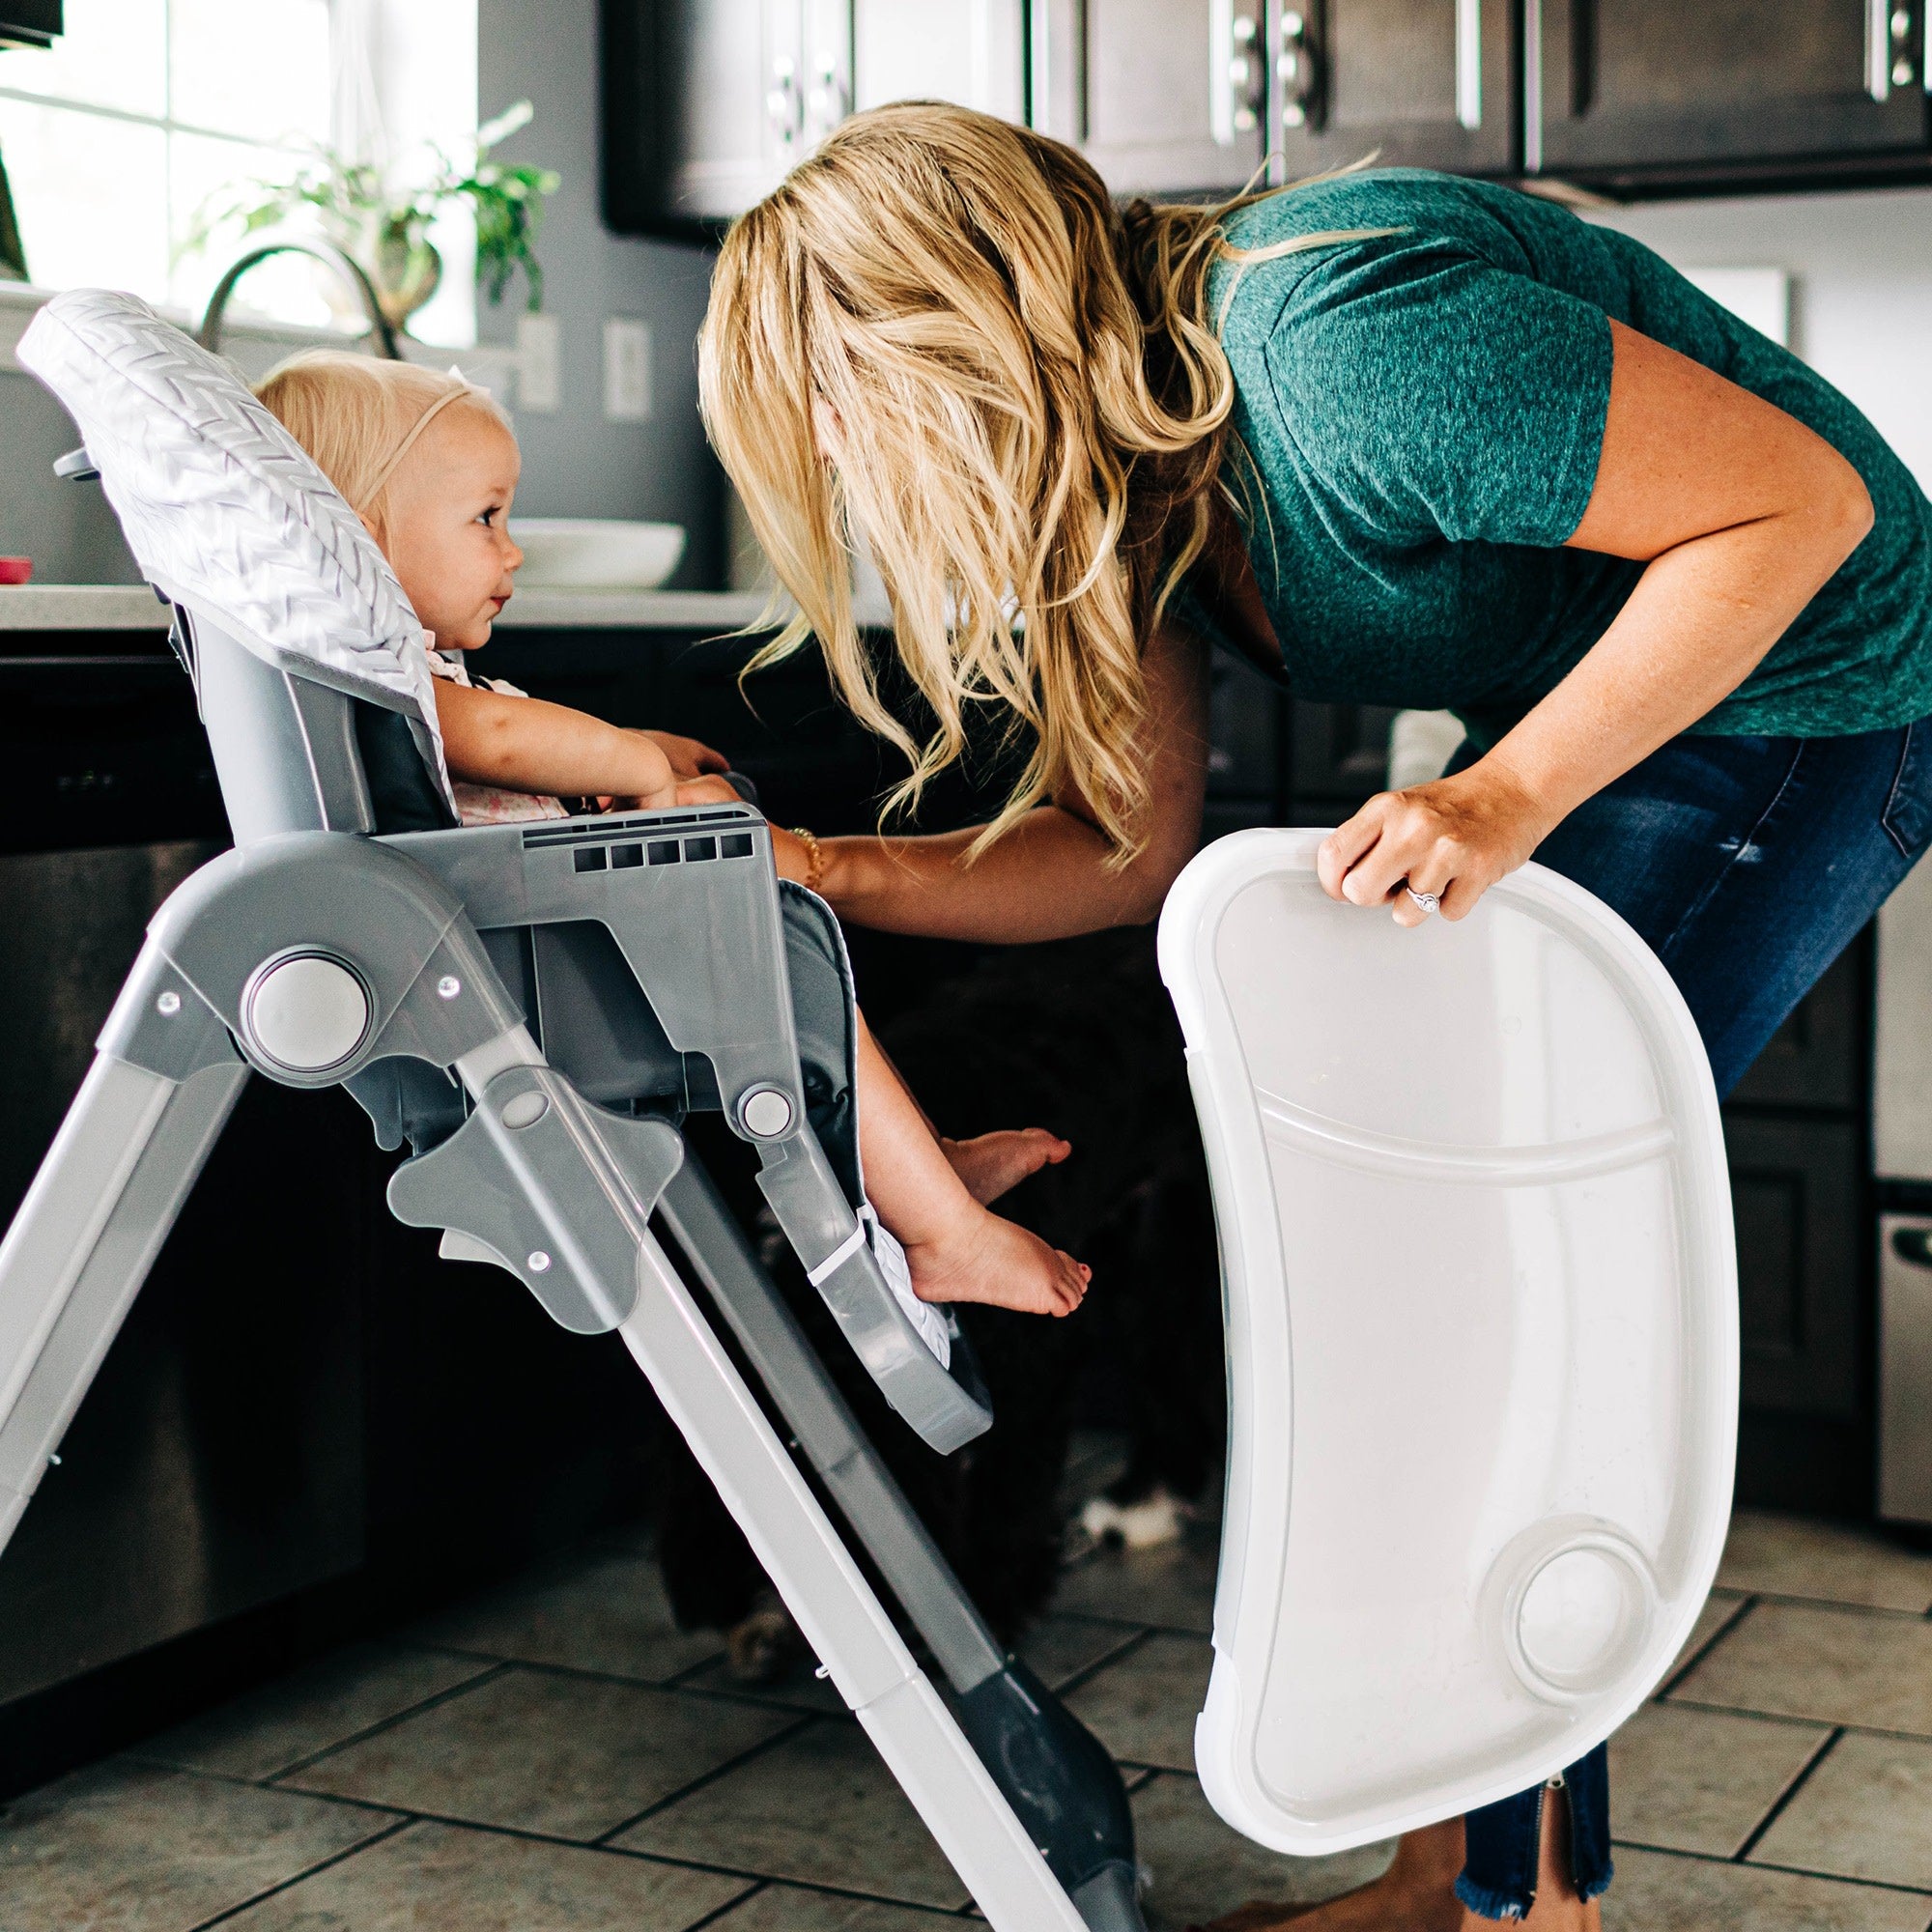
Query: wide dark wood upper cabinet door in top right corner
xmin=1524 ymin=0 xmax=1926 ymax=185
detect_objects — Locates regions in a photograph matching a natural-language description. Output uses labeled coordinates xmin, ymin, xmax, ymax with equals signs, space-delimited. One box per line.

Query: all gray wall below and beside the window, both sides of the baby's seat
xmin=0 ymin=0 xmax=723 ymax=587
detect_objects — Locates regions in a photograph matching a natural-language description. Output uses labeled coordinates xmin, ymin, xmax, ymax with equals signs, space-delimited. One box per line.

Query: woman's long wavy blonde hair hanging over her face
xmin=699 ymin=102 xmax=1352 ymax=866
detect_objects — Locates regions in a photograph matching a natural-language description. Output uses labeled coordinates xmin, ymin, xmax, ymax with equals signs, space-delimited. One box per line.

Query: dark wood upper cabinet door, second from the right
xmin=1269 ymin=0 xmax=1522 ymax=180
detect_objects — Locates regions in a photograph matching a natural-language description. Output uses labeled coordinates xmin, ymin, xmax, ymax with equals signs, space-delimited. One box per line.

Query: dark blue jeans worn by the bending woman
xmin=1451 ymin=719 xmax=1932 ymax=1918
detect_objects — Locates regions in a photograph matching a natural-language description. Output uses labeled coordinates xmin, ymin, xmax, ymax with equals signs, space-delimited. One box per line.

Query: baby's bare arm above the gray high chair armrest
xmin=435 ymin=678 xmax=678 ymax=806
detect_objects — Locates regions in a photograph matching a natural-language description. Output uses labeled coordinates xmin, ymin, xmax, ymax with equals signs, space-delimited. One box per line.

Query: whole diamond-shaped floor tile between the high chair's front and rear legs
xmin=288 ymin=1669 xmax=792 ymax=1839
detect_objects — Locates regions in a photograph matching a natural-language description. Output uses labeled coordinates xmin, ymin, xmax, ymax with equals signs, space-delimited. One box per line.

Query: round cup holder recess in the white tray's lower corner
xmin=1484 ymin=1517 xmax=1658 ymax=1704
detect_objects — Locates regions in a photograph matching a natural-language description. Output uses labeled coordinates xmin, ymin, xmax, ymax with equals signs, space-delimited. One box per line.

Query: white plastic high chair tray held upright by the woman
xmin=1161 ymin=831 xmax=1737 ymax=1855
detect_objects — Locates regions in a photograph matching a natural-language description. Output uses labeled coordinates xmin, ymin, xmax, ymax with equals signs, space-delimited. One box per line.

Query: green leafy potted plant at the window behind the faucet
xmin=182 ymin=100 xmax=558 ymax=330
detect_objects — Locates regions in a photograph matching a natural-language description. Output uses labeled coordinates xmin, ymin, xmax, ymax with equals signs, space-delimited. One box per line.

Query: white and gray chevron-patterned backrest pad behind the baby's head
xmin=17 ymin=288 xmax=448 ymax=794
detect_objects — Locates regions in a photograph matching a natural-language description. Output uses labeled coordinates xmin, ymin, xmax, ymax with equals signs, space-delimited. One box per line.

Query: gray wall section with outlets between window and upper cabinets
xmin=477 ymin=0 xmax=723 ymax=587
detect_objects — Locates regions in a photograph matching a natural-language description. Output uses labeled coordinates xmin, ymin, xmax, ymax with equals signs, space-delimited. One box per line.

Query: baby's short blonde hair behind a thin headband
xmin=255 ymin=350 xmax=510 ymax=543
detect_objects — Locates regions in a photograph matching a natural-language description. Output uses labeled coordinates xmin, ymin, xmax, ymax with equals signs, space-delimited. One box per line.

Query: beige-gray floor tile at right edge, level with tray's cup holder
xmin=1671 ymin=1604 xmax=1932 ymax=1737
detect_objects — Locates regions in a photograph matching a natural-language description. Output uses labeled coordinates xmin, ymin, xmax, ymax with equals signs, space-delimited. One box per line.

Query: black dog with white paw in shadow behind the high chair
xmin=655 ymin=927 xmax=1225 ymax=1677
